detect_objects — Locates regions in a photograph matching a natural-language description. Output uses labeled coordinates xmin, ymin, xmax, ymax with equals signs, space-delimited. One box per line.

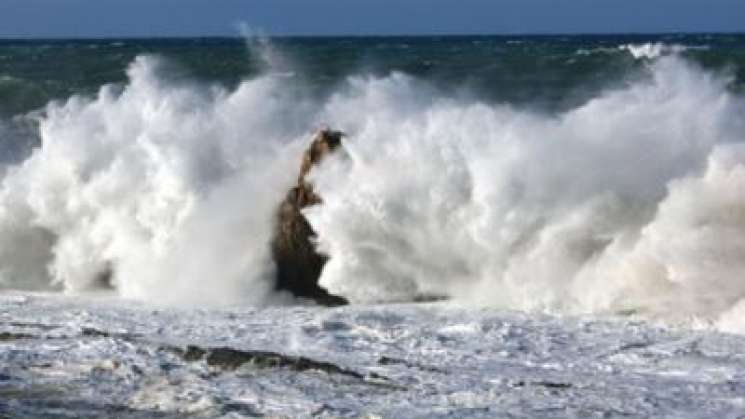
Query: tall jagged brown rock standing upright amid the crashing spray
xmin=272 ymin=129 xmax=347 ymax=306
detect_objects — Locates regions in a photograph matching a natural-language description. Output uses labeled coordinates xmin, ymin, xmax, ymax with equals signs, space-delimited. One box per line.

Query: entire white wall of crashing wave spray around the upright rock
xmin=0 ymin=37 xmax=745 ymax=330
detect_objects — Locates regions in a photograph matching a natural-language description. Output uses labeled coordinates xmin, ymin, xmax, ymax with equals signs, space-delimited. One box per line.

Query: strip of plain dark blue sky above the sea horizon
xmin=0 ymin=0 xmax=745 ymax=38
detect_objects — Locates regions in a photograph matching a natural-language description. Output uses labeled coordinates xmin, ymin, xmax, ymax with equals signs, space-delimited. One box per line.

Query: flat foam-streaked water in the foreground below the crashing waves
xmin=0 ymin=291 xmax=745 ymax=418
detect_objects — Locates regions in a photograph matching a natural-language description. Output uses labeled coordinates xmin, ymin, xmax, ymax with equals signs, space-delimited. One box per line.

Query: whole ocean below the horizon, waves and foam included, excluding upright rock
xmin=0 ymin=34 xmax=745 ymax=418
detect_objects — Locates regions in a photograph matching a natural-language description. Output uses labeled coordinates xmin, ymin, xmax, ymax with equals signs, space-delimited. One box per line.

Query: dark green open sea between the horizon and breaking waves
xmin=0 ymin=35 xmax=745 ymax=117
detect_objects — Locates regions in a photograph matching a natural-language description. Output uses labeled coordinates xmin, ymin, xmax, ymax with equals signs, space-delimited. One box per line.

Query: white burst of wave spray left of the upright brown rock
xmin=0 ymin=57 xmax=313 ymax=302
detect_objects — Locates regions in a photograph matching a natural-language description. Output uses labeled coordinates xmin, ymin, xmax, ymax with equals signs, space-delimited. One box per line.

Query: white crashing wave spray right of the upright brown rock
xmin=307 ymin=57 xmax=745 ymax=326
